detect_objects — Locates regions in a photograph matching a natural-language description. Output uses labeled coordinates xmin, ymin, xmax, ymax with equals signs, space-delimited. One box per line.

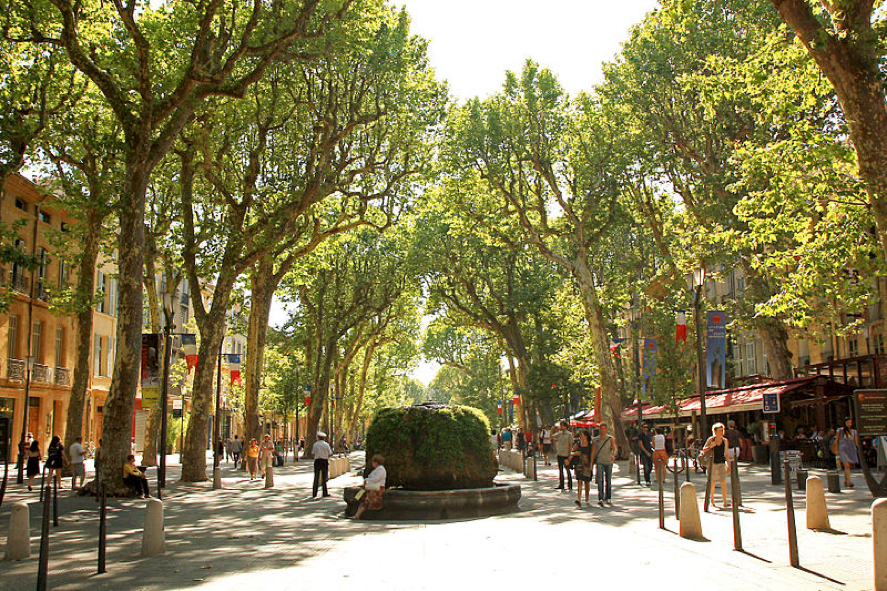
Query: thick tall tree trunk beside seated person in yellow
xmin=102 ymin=162 xmax=151 ymax=495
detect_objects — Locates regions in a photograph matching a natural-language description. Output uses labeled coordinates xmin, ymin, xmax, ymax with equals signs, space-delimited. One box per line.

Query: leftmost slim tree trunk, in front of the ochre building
xmin=65 ymin=210 xmax=101 ymax=469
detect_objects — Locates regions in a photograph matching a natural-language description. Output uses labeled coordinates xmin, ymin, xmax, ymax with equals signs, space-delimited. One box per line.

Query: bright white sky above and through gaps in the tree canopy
xmin=271 ymin=0 xmax=659 ymax=385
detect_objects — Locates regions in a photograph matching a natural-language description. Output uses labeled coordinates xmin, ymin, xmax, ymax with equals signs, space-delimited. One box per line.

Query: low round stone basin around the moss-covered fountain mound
xmin=345 ymin=484 xmax=521 ymax=521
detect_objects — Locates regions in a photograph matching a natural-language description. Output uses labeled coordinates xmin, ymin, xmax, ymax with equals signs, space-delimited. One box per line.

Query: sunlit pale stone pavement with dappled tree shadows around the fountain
xmin=0 ymin=453 xmax=873 ymax=591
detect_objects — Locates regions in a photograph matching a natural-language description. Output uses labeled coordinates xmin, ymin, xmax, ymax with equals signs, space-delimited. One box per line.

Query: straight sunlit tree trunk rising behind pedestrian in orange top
xmin=243 ymin=257 xmax=278 ymax=454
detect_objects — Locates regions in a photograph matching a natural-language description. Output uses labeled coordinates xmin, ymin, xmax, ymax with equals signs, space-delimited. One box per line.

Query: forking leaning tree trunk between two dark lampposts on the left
xmin=182 ymin=320 xmax=227 ymax=482
